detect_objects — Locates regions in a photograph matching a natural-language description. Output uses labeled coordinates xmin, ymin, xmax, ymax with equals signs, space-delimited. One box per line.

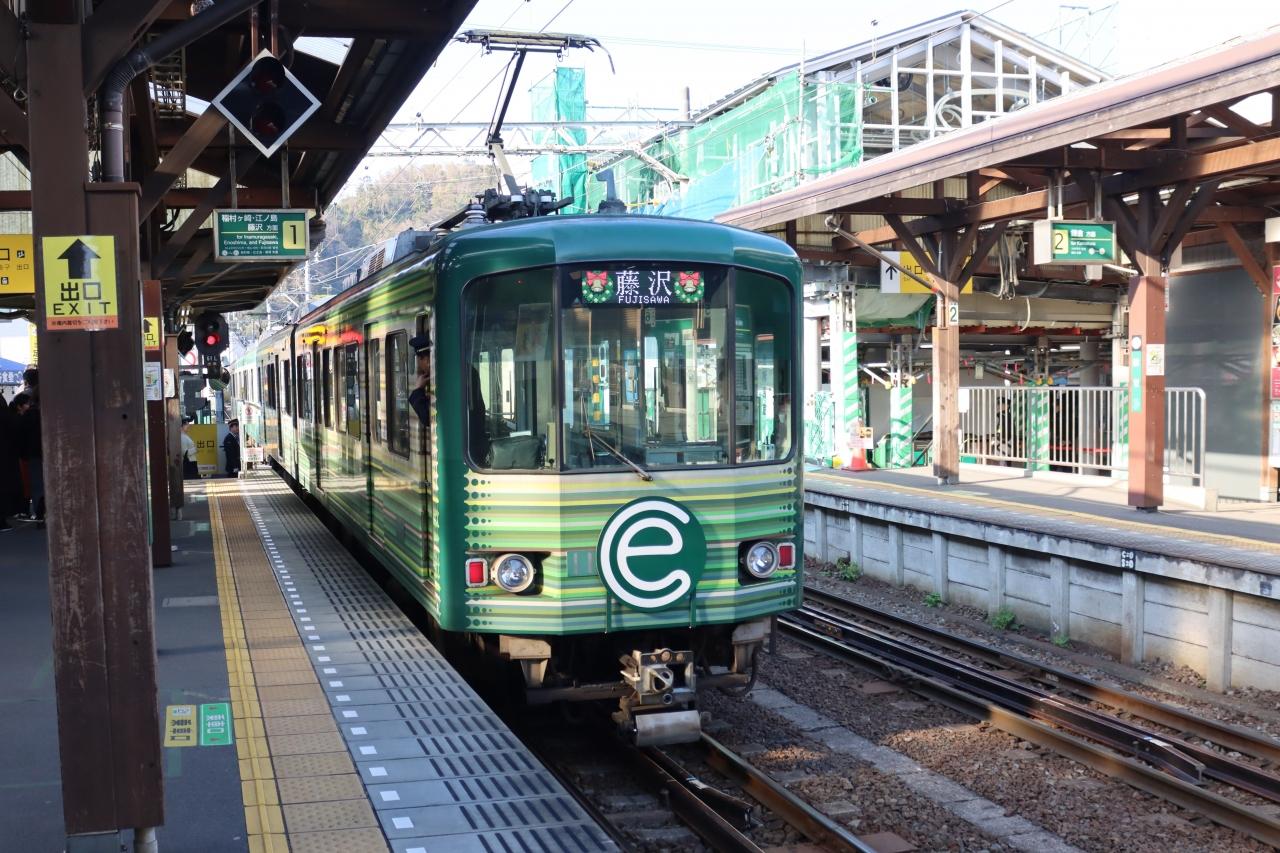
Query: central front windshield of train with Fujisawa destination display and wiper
xmin=561 ymin=264 xmax=732 ymax=470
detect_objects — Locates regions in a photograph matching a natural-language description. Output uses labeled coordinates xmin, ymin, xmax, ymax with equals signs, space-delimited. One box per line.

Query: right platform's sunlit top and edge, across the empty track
xmin=805 ymin=465 xmax=1280 ymax=575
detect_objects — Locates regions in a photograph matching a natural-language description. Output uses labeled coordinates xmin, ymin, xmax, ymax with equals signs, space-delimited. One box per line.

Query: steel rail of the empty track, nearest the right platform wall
xmin=805 ymin=587 xmax=1280 ymax=802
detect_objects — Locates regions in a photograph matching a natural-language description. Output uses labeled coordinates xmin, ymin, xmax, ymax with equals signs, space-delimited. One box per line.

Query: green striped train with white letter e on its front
xmin=233 ymin=214 xmax=804 ymax=743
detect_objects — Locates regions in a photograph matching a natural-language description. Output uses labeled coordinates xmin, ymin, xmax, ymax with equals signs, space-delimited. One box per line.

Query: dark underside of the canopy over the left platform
xmin=0 ymin=0 xmax=475 ymax=314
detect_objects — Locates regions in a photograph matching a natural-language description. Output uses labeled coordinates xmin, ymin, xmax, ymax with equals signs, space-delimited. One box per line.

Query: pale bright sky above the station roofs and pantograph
xmin=355 ymin=0 xmax=1280 ymax=172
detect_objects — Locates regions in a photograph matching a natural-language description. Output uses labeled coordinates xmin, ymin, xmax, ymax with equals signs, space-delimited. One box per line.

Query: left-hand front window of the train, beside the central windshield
xmin=462 ymin=269 xmax=557 ymax=470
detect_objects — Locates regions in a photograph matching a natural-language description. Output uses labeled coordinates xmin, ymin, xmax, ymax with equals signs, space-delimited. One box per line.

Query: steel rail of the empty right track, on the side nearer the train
xmin=778 ymin=616 xmax=1280 ymax=847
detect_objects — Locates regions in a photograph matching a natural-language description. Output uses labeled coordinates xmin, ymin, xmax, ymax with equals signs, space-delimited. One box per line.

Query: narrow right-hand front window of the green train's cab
xmin=733 ymin=270 xmax=795 ymax=462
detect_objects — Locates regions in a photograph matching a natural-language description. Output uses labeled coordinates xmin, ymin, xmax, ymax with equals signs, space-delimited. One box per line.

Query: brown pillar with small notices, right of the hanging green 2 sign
xmin=1129 ymin=274 xmax=1169 ymax=511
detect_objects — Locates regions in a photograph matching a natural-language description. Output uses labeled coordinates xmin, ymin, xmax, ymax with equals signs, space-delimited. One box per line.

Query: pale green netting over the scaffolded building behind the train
xmin=578 ymin=72 xmax=863 ymax=219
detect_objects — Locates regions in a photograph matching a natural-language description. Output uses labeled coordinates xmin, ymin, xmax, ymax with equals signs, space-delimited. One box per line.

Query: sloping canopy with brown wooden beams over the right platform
xmin=717 ymin=32 xmax=1280 ymax=302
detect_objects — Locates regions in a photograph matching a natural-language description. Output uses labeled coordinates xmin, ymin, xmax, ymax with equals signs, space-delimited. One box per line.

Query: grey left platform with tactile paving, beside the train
xmin=0 ymin=473 xmax=613 ymax=853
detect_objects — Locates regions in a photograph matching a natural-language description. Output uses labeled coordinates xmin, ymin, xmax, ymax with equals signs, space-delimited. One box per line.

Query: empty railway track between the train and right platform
xmin=778 ymin=588 xmax=1280 ymax=847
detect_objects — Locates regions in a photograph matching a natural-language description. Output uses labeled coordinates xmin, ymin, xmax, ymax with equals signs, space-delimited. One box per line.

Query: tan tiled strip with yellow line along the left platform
xmin=209 ymin=483 xmax=388 ymax=853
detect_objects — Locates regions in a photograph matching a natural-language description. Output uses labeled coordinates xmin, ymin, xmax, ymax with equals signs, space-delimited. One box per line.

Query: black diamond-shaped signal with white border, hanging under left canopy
xmin=212 ymin=50 xmax=320 ymax=158
